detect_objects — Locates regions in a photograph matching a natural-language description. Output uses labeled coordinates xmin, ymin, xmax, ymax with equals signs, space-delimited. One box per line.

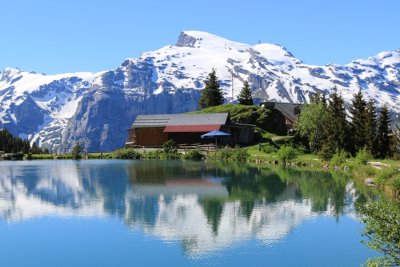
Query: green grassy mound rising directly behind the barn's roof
xmin=190 ymin=104 xmax=286 ymax=135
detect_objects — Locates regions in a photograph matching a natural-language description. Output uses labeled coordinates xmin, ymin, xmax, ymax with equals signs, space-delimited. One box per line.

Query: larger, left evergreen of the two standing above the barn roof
xmin=199 ymin=69 xmax=224 ymax=108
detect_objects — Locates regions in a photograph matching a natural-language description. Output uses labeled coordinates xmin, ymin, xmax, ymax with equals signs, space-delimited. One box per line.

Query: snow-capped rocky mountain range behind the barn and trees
xmin=0 ymin=31 xmax=400 ymax=151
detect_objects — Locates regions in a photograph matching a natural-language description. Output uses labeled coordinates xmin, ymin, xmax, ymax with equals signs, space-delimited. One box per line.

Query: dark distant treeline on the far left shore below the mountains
xmin=0 ymin=129 xmax=48 ymax=154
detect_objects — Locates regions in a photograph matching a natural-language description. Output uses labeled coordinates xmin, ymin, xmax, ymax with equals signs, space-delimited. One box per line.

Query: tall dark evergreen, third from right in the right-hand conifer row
xmin=350 ymin=90 xmax=367 ymax=154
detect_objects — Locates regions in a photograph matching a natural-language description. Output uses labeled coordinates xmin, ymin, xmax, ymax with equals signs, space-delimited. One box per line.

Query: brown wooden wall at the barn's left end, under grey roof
xmin=129 ymin=127 xmax=168 ymax=146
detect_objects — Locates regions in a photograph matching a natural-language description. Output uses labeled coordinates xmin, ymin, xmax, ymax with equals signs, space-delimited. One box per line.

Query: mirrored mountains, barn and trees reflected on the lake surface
xmin=0 ymin=161 xmax=368 ymax=257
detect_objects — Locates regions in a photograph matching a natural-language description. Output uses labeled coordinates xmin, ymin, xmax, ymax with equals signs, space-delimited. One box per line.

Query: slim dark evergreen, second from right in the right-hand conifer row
xmin=365 ymin=100 xmax=377 ymax=156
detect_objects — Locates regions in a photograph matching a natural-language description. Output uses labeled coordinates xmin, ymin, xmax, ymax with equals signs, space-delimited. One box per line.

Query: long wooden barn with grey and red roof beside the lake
xmin=126 ymin=113 xmax=255 ymax=147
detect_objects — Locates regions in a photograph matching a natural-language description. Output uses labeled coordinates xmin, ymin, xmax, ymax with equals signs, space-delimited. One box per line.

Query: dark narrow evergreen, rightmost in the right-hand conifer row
xmin=377 ymin=105 xmax=390 ymax=158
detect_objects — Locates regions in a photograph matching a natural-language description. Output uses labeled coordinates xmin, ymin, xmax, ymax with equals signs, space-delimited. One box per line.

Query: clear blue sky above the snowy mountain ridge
xmin=0 ymin=0 xmax=400 ymax=74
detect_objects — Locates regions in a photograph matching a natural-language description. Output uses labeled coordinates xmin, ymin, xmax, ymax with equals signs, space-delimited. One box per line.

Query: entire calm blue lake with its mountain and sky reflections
xmin=0 ymin=160 xmax=376 ymax=267
